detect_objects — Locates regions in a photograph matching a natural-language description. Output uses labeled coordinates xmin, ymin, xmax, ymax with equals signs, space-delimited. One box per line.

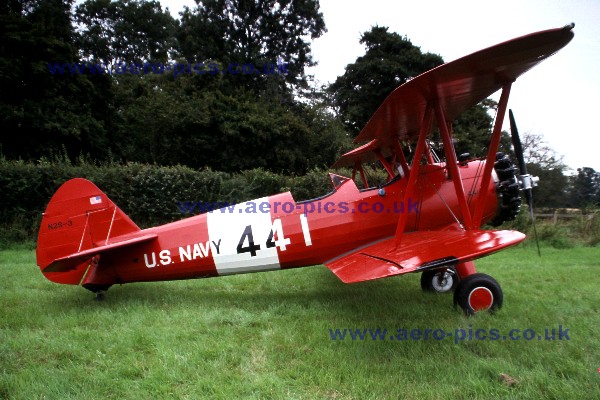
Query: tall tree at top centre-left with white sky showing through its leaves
xmin=177 ymin=0 xmax=325 ymax=89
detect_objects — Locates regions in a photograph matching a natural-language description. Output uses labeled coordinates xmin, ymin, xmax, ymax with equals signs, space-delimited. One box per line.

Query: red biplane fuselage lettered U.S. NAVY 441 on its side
xmin=38 ymin=160 xmax=497 ymax=287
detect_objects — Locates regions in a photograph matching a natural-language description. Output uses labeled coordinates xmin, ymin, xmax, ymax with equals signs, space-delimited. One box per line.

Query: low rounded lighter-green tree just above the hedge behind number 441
xmin=183 ymin=89 xmax=346 ymax=174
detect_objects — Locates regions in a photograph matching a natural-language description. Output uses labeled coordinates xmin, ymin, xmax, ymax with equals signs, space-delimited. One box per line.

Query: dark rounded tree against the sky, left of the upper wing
xmin=328 ymin=26 xmax=443 ymax=136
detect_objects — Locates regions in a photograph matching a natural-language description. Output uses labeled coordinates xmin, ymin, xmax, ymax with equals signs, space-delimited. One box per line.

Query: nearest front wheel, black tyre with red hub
xmin=454 ymin=273 xmax=502 ymax=315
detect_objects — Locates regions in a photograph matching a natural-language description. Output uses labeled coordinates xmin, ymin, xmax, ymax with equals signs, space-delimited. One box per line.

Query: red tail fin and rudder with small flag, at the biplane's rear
xmin=36 ymin=178 xmax=142 ymax=285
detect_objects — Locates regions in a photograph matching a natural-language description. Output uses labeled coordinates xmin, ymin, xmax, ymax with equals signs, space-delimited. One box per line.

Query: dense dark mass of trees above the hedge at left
xmin=0 ymin=0 xmax=348 ymax=173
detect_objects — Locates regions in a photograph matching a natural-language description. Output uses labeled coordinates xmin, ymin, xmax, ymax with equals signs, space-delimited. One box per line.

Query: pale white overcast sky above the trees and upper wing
xmin=161 ymin=0 xmax=600 ymax=172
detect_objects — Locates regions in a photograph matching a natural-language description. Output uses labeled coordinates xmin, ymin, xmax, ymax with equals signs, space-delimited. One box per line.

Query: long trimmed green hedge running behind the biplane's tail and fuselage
xmin=0 ymin=158 xmax=340 ymax=247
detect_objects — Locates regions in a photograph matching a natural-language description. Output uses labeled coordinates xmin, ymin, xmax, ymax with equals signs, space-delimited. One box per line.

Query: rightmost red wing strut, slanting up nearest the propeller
xmin=473 ymin=82 xmax=512 ymax=227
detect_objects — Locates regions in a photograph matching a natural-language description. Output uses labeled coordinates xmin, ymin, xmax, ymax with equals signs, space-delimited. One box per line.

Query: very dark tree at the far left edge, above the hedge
xmin=0 ymin=0 xmax=106 ymax=158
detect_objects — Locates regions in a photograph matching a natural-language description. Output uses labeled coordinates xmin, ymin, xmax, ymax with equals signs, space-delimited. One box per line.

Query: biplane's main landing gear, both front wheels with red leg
xmin=421 ymin=261 xmax=503 ymax=316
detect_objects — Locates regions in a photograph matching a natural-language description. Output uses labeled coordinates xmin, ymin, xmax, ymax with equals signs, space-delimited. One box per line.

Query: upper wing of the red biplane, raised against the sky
xmin=334 ymin=25 xmax=574 ymax=167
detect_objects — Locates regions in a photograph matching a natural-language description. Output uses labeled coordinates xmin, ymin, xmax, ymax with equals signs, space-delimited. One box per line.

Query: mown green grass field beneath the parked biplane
xmin=0 ymin=247 xmax=600 ymax=399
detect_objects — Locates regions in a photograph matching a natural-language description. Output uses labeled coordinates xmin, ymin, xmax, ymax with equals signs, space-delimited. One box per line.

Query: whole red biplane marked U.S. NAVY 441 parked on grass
xmin=37 ymin=25 xmax=573 ymax=314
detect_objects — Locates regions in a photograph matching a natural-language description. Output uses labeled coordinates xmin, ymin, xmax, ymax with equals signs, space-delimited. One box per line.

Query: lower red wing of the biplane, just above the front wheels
xmin=325 ymin=230 xmax=525 ymax=283
